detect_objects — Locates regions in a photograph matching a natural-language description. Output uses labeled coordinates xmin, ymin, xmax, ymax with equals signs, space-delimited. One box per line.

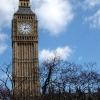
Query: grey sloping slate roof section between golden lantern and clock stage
xmin=15 ymin=7 xmax=34 ymax=14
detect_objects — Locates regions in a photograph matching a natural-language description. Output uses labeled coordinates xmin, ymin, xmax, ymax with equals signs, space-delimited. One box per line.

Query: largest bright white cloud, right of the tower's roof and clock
xmin=32 ymin=0 xmax=74 ymax=35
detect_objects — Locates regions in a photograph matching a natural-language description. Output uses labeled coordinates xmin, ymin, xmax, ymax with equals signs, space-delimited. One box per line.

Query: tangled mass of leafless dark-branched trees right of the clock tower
xmin=41 ymin=57 xmax=100 ymax=100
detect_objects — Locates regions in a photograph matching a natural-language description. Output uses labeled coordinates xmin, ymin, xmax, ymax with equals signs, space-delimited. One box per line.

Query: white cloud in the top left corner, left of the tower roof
xmin=0 ymin=0 xmax=18 ymax=27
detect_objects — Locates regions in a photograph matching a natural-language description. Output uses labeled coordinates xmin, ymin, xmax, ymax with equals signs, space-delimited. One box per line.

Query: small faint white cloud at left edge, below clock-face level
xmin=0 ymin=33 xmax=8 ymax=54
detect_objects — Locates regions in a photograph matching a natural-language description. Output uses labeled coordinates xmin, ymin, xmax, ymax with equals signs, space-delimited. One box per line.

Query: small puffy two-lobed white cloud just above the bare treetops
xmin=39 ymin=46 xmax=72 ymax=61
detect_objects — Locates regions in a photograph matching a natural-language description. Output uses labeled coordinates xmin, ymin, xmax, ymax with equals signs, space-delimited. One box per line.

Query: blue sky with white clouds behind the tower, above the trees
xmin=0 ymin=0 xmax=100 ymax=69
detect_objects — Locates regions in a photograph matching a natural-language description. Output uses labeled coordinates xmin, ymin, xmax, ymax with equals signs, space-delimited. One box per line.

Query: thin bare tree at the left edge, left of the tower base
xmin=0 ymin=64 xmax=12 ymax=100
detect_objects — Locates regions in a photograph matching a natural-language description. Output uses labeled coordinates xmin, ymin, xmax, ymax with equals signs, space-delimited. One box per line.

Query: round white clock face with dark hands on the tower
xmin=18 ymin=22 xmax=32 ymax=34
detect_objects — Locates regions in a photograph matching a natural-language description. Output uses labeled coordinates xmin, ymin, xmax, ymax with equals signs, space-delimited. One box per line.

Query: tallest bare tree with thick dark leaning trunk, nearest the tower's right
xmin=40 ymin=57 xmax=60 ymax=94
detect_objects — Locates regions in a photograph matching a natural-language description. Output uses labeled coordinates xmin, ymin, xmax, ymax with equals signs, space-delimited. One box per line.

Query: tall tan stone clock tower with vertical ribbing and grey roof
xmin=12 ymin=0 xmax=40 ymax=100
